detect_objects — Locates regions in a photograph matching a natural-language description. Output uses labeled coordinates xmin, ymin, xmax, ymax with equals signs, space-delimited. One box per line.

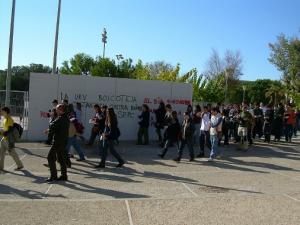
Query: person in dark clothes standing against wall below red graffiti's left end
xmin=137 ymin=104 xmax=150 ymax=145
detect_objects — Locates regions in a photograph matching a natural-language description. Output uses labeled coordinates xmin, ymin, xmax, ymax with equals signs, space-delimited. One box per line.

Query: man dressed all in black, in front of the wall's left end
xmin=46 ymin=105 xmax=70 ymax=182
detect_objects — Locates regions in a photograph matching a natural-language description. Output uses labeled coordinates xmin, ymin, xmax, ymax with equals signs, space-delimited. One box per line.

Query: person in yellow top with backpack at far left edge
xmin=0 ymin=107 xmax=24 ymax=172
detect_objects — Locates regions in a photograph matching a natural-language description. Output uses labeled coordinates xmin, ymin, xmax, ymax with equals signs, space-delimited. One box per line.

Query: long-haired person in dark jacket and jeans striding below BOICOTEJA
xmin=96 ymin=108 xmax=125 ymax=168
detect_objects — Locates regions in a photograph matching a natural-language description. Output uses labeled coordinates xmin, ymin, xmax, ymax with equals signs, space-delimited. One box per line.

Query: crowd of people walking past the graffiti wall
xmin=0 ymin=97 xmax=300 ymax=182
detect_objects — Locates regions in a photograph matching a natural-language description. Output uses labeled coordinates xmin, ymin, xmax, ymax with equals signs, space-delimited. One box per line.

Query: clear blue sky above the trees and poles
xmin=0 ymin=0 xmax=300 ymax=80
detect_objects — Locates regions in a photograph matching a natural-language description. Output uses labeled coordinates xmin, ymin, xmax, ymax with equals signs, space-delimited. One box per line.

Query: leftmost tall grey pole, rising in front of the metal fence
xmin=5 ymin=0 xmax=16 ymax=107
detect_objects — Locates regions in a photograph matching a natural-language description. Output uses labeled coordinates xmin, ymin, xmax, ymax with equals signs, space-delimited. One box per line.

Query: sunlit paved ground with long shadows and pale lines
xmin=0 ymin=137 xmax=300 ymax=225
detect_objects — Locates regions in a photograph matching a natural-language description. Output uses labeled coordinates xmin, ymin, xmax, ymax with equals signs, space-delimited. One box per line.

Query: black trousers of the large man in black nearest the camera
xmin=47 ymin=144 xmax=68 ymax=178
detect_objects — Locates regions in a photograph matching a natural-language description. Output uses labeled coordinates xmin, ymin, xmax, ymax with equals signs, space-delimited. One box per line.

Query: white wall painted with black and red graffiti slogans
xmin=28 ymin=73 xmax=192 ymax=140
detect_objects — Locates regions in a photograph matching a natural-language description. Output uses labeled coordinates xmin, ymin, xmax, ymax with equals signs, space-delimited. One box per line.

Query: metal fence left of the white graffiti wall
xmin=0 ymin=90 xmax=29 ymax=139
